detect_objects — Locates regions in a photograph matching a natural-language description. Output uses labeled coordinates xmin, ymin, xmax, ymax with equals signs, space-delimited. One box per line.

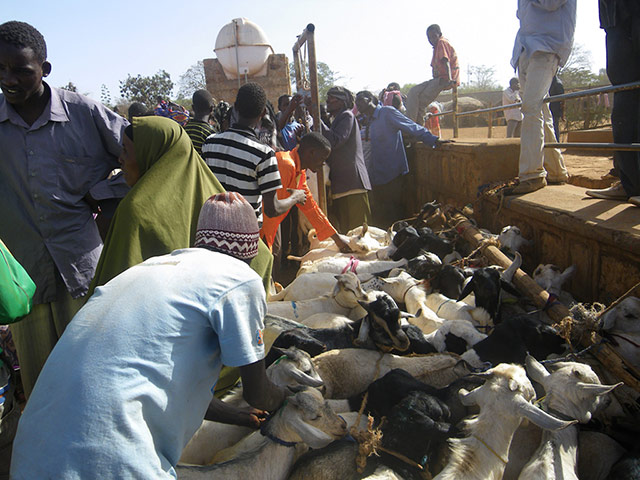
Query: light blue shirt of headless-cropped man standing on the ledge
xmin=511 ymin=0 xmax=576 ymax=69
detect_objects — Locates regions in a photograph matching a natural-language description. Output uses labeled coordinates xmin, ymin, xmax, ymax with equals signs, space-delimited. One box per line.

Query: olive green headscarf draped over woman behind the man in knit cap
xmin=89 ymin=117 xmax=273 ymax=293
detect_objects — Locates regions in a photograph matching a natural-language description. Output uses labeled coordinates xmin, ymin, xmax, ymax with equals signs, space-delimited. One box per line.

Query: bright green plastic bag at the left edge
xmin=0 ymin=240 xmax=36 ymax=324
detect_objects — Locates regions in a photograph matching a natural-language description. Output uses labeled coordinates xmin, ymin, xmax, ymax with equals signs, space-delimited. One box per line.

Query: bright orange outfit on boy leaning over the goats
xmin=260 ymin=147 xmax=337 ymax=248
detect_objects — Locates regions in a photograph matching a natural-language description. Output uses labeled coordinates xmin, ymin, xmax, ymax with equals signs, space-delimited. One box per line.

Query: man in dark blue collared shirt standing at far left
xmin=0 ymin=21 xmax=128 ymax=396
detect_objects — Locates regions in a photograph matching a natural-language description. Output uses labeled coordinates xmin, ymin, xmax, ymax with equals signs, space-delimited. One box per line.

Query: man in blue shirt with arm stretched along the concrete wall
xmin=356 ymin=90 xmax=449 ymax=228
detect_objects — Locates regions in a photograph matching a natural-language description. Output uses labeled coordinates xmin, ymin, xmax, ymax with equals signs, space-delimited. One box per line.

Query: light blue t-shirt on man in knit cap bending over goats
xmin=11 ymin=248 xmax=266 ymax=480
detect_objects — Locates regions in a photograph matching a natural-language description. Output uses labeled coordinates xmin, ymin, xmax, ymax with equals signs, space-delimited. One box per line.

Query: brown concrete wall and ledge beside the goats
xmin=406 ymin=139 xmax=640 ymax=303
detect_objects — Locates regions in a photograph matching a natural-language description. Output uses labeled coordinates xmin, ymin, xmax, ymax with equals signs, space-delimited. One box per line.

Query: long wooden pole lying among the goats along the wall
xmin=452 ymin=214 xmax=640 ymax=392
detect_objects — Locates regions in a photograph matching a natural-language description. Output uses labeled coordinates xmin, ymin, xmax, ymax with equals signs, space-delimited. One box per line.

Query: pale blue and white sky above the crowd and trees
xmin=0 ymin=0 xmax=606 ymax=101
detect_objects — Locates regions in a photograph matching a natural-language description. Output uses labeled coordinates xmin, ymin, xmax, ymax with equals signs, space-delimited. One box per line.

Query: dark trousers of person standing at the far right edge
xmin=606 ymin=15 xmax=640 ymax=196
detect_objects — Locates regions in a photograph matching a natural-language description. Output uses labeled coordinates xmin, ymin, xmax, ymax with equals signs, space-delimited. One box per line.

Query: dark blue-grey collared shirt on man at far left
xmin=0 ymin=86 xmax=128 ymax=304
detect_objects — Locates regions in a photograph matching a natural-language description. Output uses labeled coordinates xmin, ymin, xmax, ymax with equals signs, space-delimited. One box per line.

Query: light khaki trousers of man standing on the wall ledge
xmin=518 ymin=52 xmax=569 ymax=182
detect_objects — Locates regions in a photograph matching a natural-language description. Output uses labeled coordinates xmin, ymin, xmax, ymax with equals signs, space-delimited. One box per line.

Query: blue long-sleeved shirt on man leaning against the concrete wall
xmin=365 ymin=105 xmax=438 ymax=186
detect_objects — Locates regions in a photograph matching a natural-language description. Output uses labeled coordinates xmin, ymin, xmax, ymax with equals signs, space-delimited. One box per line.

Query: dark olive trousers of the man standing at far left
xmin=10 ymin=279 xmax=85 ymax=399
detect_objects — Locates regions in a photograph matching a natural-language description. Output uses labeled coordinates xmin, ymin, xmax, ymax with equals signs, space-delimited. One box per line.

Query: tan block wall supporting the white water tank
xmin=202 ymin=53 xmax=291 ymax=111
